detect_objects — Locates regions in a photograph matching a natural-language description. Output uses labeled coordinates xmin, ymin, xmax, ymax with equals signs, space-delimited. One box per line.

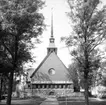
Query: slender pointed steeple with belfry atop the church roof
xmin=47 ymin=9 xmax=57 ymax=54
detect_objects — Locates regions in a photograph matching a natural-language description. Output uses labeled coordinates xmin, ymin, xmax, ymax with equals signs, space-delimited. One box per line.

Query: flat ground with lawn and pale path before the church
xmin=0 ymin=97 xmax=106 ymax=105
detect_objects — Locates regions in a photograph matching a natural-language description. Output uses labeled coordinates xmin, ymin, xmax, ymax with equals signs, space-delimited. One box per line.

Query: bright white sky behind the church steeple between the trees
xmin=28 ymin=0 xmax=106 ymax=68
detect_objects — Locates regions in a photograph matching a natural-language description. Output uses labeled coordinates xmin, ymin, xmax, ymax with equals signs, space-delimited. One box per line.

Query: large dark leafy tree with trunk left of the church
xmin=0 ymin=0 xmax=44 ymax=105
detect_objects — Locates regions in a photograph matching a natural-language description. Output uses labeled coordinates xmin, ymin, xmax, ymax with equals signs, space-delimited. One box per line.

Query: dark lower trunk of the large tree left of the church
xmin=7 ymin=71 xmax=14 ymax=105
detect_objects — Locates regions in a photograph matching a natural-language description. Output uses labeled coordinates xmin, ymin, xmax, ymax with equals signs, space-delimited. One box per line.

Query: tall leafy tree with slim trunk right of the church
xmin=65 ymin=0 xmax=106 ymax=105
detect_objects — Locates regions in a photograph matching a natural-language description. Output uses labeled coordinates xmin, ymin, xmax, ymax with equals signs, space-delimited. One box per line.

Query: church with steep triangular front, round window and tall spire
xmin=30 ymin=11 xmax=73 ymax=95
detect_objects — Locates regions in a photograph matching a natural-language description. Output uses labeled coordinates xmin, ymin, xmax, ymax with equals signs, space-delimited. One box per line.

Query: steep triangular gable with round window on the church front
xmin=31 ymin=52 xmax=68 ymax=82
